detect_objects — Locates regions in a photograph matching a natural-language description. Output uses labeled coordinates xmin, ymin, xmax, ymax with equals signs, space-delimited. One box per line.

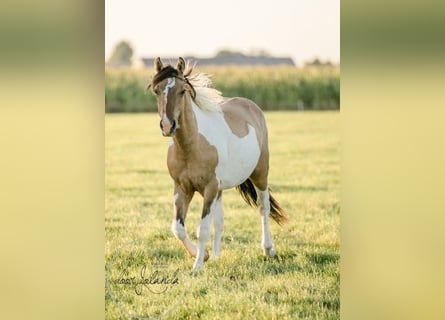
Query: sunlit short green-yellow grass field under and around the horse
xmin=105 ymin=112 xmax=340 ymax=319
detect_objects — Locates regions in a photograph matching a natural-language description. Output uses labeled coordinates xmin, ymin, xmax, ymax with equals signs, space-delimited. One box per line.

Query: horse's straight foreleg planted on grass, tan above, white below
xmin=193 ymin=187 xmax=218 ymax=271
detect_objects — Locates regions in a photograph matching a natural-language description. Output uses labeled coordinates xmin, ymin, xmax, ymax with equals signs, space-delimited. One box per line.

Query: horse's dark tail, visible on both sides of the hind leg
xmin=236 ymin=179 xmax=288 ymax=226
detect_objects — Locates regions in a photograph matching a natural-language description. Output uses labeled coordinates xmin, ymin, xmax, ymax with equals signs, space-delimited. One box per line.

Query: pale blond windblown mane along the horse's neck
xmin=184 ymin=62 xmax=224 ymax=112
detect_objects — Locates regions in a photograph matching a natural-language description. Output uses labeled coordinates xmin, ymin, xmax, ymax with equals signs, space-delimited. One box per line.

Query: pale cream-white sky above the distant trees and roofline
xmin=105 ymin=0 xmax=340 ymax=65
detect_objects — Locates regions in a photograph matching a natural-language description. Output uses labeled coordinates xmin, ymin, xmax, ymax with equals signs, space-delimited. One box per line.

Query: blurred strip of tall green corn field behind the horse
xmin=105 ymin=65 xmax=340 ymax=113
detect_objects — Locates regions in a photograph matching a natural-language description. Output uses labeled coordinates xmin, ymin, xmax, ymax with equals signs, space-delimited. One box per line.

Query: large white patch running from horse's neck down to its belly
xmin=192 ymin=101 xmax=261 ymax=189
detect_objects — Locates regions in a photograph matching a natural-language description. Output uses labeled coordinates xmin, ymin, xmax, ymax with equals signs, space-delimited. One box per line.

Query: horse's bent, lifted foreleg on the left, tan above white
xmin=172 ymin=187 xmax=196 ymax=257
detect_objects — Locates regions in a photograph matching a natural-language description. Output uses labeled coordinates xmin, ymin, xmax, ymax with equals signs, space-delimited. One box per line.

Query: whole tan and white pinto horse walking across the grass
xmin=147 ymin=57 xmax=288 ymax=271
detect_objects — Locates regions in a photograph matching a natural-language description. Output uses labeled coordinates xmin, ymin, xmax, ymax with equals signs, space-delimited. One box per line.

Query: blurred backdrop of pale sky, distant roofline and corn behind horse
xmin=105 ymin=0 xmax=340 ymax=113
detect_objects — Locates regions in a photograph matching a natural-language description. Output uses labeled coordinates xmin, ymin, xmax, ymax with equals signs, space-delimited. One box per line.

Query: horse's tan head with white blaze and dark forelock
xmin=149 ymin=58 xmax=195 ymax=137
